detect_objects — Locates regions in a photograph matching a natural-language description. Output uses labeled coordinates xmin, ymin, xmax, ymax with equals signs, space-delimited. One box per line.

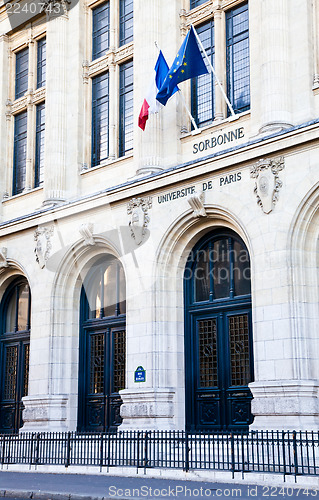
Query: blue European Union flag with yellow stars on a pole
xmin=156 ymin=26 xmax=208 ymax=106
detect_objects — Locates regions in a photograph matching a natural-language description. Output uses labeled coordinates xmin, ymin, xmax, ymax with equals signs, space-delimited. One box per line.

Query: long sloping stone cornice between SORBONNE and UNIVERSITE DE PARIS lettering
xmin=0 ymin=119 xmax=319 ymax=237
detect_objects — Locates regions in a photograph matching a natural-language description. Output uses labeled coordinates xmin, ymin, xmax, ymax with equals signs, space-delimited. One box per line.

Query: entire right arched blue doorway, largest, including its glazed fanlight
xmin=184 ymin=231 xmax=253 ymax=430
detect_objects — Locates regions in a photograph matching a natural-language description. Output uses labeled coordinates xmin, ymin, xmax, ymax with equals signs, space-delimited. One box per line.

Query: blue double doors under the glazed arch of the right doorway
xmin=186 ymin=310 xmax=252 ymax=430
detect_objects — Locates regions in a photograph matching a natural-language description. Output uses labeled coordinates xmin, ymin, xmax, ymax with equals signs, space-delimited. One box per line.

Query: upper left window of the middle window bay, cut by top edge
xmin=92 ymin=2 xmax=110 ymax=60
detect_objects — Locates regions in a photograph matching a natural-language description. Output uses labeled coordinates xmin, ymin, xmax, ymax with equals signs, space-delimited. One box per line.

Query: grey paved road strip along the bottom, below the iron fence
xmin=0 ymin=469 xmax=319 ymax=500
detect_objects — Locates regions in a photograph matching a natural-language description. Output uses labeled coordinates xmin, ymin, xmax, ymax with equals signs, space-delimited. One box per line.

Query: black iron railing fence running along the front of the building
xmin=0 ymin=431 xmax=319 ymax=476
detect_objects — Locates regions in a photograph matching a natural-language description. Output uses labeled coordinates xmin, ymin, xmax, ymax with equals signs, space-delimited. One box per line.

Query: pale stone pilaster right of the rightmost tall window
xmin=260 ymin=0 xmax=291 ymax=132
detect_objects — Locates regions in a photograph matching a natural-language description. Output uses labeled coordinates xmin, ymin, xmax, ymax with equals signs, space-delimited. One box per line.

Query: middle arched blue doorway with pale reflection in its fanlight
xmin=78 ymin=255 xmax=126 ymax=432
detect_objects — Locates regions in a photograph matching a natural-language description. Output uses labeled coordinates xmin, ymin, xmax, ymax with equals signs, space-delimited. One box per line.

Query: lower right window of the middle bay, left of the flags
xmin=119 ymin=61 xmax=133 ymax=156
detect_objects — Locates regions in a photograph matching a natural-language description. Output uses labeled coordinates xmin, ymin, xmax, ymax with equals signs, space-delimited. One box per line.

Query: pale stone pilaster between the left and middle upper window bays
xmin=44 ymin=8 xmax=68 ymax=205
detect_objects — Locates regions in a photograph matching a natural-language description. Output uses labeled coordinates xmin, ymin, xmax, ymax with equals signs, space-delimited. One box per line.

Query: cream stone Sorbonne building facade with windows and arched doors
xmin=0 ymin=0 xmax=319 ymax=432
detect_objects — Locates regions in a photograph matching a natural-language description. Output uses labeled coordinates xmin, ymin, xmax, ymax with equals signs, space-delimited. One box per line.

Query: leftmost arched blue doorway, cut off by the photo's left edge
xmin=0 ymin=278 xmax=31 ymax=433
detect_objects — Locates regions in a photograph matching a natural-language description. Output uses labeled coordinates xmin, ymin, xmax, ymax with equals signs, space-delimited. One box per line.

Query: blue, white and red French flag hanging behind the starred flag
xmin=138 ymin=51 xmax=179 ymax=130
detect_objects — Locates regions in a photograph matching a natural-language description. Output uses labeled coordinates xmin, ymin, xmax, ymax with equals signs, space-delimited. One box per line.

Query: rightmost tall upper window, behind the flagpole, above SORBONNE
xmin=226 ymin=4 xmax=250 ymax=112
